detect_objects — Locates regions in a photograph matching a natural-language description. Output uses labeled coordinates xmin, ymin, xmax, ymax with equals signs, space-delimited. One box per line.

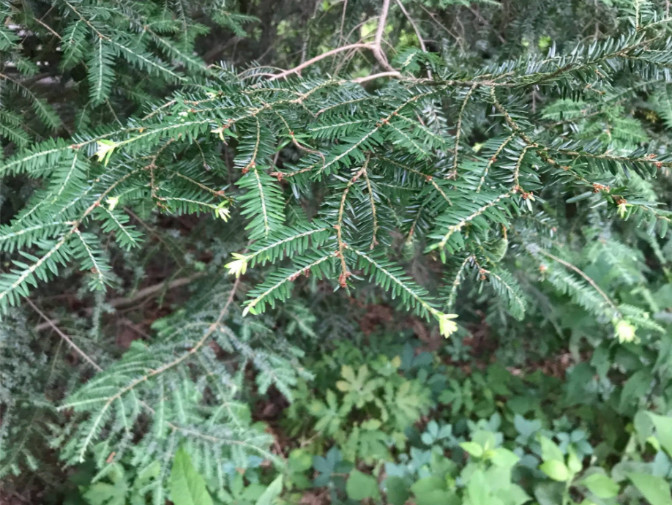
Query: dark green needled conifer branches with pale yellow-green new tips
xmin=0 ymin=0 xmax=672 ymax=503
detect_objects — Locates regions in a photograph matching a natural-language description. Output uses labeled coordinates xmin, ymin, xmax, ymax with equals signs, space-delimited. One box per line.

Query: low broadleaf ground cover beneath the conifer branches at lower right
xmin=268 ymin=339 xmax=672 ymax=505
